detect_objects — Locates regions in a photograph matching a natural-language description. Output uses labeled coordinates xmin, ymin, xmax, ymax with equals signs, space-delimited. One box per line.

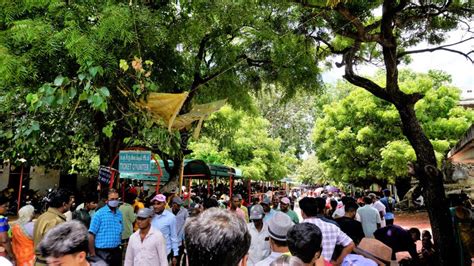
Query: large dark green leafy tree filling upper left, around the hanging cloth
xmin=0 ymin=0 xmax=319 ymax=181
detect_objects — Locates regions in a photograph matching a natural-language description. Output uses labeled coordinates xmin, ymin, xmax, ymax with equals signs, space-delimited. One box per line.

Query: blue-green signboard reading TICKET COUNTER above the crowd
xmin=119 ymin=151 xmax=151 ymax=174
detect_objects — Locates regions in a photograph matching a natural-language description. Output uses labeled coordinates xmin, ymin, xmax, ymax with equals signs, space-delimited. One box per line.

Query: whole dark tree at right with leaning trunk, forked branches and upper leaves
xmin=295 ymin=0 xmax=474 ymax=265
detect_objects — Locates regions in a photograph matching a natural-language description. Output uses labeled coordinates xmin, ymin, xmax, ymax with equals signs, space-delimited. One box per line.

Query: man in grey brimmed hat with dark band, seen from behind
xmin=255 ymin=212 xmax=294 ymax=266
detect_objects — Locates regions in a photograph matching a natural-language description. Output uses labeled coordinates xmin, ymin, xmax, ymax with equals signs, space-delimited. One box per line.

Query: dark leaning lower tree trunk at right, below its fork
xmin=395 ymin=103 xmax=459 ymax=266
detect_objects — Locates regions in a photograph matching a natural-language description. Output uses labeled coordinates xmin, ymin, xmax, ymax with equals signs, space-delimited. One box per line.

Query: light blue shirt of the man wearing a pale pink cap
xmin=152 ymin=210 xmax=179 ymax=257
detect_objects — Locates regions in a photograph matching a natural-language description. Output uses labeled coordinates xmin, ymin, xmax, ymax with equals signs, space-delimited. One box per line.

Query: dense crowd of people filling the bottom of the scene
xmin=0 ymin=184 xmax=472 ymax=266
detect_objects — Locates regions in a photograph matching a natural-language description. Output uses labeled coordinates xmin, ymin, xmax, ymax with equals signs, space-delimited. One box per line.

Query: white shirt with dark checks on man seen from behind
xmin=303 ymin=217 xmax=352 ymax=261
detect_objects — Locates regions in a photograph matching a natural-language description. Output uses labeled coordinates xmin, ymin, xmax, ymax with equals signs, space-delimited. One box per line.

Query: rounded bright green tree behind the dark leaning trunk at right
xmin=313 ymin=70 xmax=474 ymax=186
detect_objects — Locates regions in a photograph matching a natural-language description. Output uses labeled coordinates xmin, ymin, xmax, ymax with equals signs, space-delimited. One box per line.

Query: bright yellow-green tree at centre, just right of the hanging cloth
xmin=190 ymin=106 xmax=297 ymax=181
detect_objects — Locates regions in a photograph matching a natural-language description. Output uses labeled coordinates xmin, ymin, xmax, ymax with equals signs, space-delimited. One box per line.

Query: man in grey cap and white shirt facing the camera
xmin=124 ymin=208 xmax=168 ymax=266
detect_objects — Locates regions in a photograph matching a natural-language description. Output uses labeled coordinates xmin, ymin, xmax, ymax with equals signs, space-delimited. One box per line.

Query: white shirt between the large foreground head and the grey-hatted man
xmin=247 ymin=222 xmax=271 ymax=266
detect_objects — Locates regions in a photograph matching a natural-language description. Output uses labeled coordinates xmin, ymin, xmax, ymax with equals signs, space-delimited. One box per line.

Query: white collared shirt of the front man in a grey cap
xmin=124 ymin=228 xmax=168 ymax=266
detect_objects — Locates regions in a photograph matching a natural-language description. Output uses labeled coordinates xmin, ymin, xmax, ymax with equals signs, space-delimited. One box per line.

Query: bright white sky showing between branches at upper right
xmin=323 ymin=27 xmax=474 ymax=94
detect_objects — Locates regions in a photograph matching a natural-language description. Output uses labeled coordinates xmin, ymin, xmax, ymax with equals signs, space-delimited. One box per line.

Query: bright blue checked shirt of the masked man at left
xmin=89 ymin=205 xmax=123 ymax=248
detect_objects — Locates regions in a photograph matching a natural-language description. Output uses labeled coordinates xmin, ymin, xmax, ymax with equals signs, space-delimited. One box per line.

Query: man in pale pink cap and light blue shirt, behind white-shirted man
xmin=151 ymin=194 xmax=179 ymax=265
